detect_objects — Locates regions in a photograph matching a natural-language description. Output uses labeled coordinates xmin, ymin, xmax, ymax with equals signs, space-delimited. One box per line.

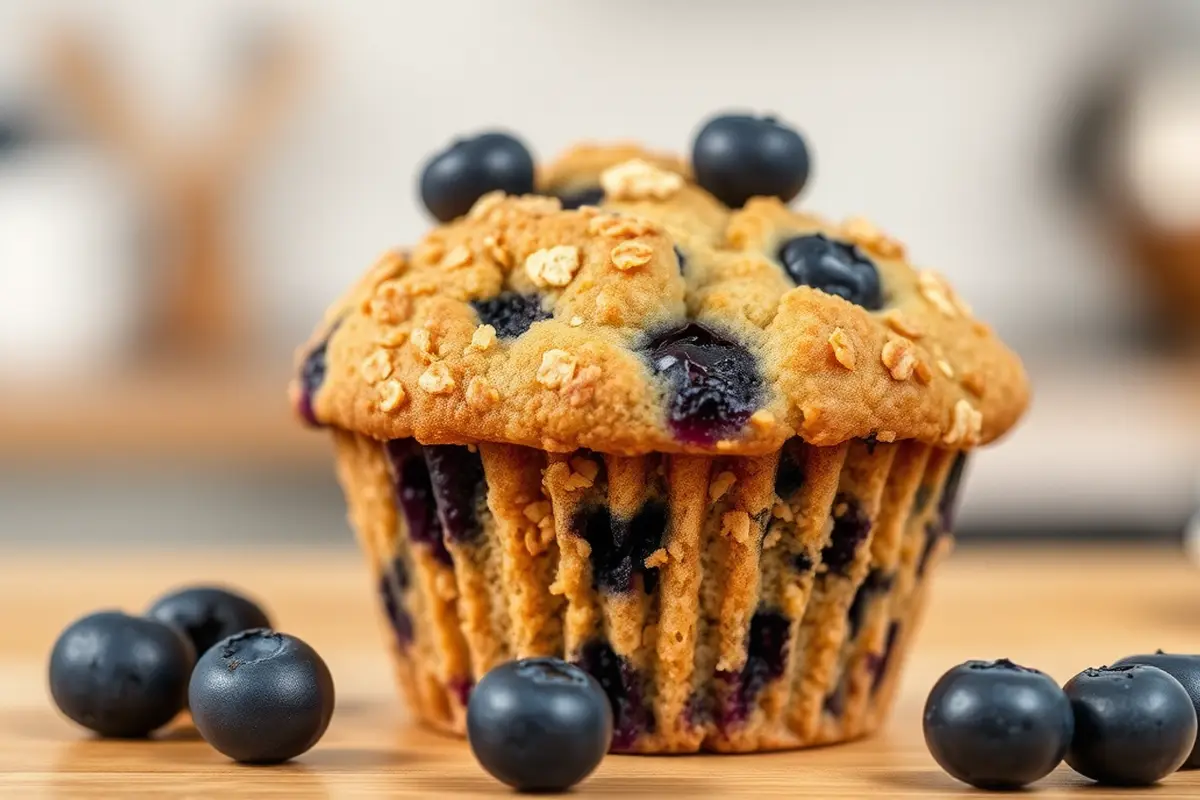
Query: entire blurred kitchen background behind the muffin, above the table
xmin=0 ymin=0 xmax=1200 ymax=548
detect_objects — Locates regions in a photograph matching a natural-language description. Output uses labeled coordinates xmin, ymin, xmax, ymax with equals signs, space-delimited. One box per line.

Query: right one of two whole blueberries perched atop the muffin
xmin=691 ymin=114 xmax=809 ymax=209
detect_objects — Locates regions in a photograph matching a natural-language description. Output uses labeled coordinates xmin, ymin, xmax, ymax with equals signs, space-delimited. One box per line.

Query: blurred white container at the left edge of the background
xmin=0 ymin=109 xmax=142 ymax=383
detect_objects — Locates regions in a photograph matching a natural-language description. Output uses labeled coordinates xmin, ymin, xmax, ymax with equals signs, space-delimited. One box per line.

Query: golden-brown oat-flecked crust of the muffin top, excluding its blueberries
xmin=295 ymin=146 xmax=1028 ymax=455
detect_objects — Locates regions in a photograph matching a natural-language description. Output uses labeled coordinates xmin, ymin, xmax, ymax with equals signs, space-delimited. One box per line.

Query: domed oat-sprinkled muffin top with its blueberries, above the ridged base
xmin=293 ymin=118 xmax=1028 ymax=455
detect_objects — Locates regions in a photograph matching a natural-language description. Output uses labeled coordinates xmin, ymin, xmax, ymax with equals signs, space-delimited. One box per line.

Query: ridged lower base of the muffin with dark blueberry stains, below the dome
xmin=334 ymin=431 xmax=964 ymax=753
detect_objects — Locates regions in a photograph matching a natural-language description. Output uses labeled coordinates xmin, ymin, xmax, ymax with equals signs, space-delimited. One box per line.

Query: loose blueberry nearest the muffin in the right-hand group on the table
xmin=924 ymin=660 xmax=1074 ymax=789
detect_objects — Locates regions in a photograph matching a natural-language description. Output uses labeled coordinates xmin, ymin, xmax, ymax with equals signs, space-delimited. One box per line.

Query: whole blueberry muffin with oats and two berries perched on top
xmin=293 ymin=116 xmax=1027 ymax=753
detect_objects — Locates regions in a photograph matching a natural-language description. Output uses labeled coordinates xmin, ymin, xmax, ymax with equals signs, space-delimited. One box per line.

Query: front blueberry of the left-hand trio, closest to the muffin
xmin=187 ymin=628 xmax=334 ymax=764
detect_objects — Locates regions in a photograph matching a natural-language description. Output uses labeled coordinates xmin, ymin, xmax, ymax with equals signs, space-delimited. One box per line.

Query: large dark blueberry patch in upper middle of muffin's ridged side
xmin=572 ymin=500 xmax=670 ymax=594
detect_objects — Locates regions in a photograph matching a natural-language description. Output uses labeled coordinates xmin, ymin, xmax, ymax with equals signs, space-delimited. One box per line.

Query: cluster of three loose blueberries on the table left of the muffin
xmin=49 ymin=587 xmax=334 ymax=763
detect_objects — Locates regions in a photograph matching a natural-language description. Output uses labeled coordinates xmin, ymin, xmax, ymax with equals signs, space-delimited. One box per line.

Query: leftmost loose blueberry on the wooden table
xmin=50 ymin=612 xmax=196 ymax=738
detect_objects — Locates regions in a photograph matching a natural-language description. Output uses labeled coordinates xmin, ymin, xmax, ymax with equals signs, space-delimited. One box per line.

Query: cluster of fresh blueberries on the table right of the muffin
xmin=924 ymin=650 xmax=1200 ymax=789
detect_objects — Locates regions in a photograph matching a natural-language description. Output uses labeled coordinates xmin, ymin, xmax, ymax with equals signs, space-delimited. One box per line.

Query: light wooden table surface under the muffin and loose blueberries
xmin=0 ymin=547 xmax=1200 ymax=800
